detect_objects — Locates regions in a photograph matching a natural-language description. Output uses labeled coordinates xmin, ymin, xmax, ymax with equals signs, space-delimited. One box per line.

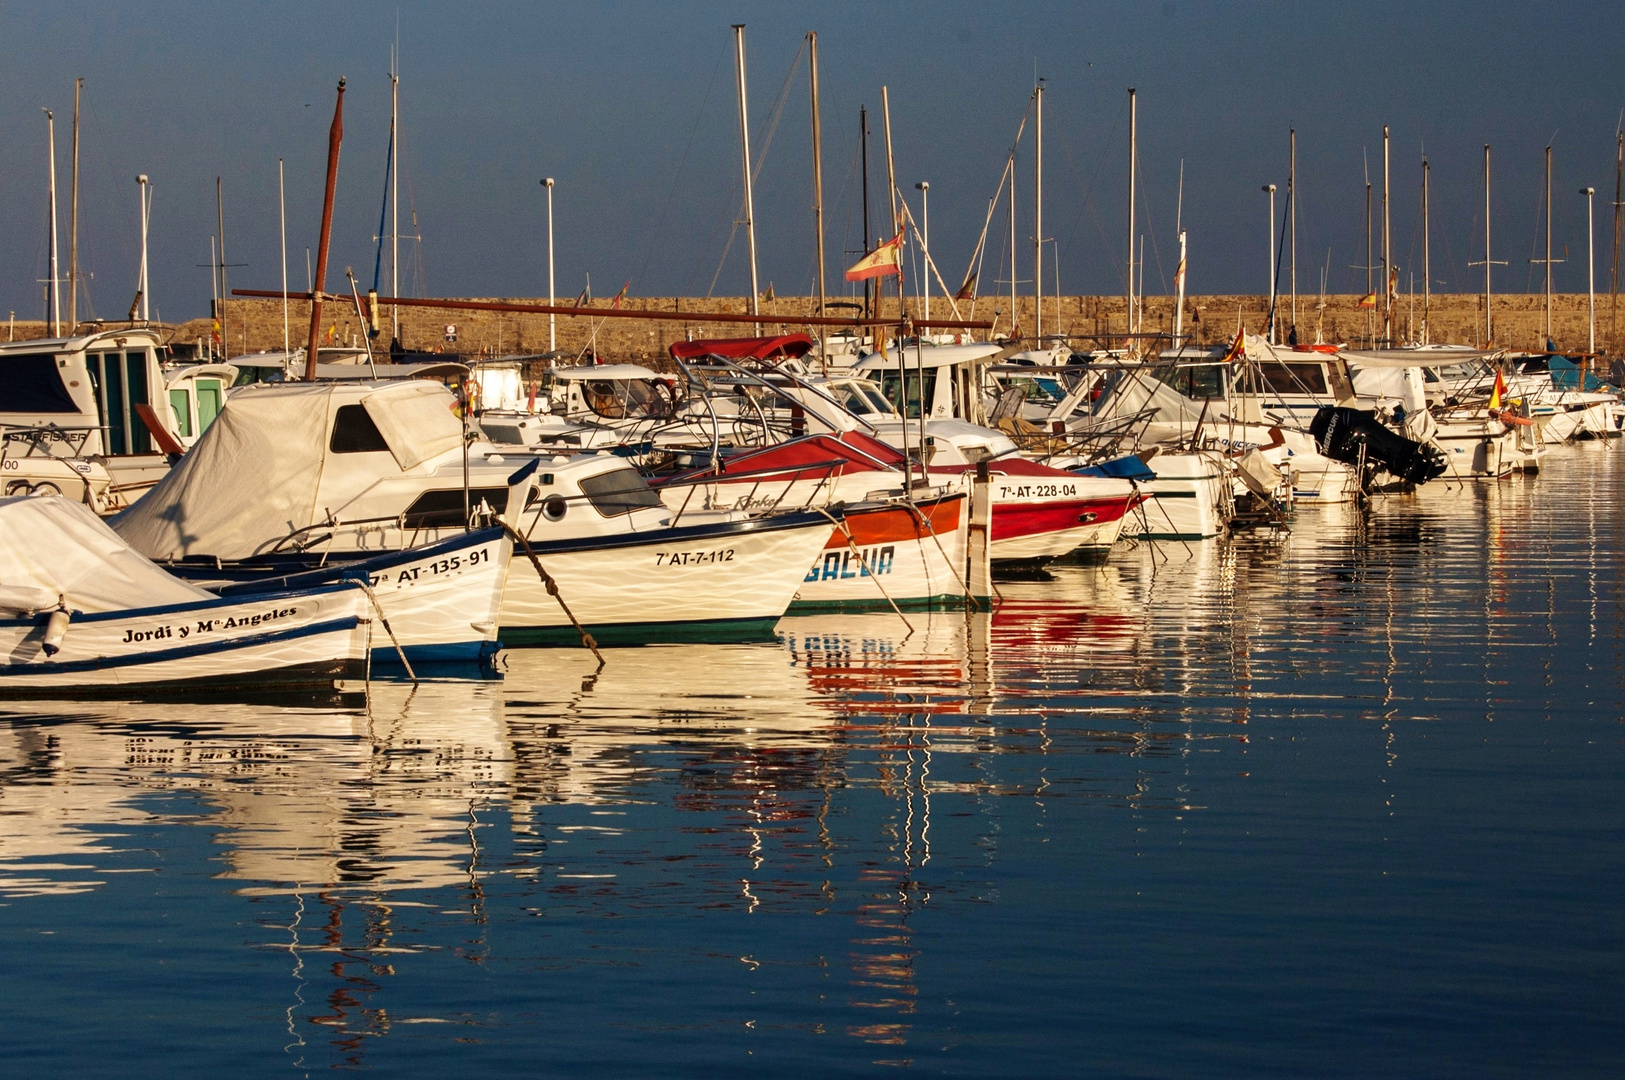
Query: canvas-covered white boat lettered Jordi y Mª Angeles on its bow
xmin=0 ymin=495 xmax=371 ymax=697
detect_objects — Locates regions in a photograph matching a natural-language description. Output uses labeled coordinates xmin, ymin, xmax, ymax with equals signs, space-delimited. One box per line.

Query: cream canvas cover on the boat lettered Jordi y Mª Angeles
xmin=0 ymin=495 xmax=213 ymax=616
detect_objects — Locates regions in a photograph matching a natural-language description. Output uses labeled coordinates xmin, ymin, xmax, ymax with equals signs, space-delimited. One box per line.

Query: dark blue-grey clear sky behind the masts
xmin=0 ymin=0 xmax=1625 ymax=320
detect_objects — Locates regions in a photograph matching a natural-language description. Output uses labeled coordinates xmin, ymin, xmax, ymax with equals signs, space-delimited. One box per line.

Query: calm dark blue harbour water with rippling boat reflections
xmin=0 ymin=447 xmax=1625 ymax=1077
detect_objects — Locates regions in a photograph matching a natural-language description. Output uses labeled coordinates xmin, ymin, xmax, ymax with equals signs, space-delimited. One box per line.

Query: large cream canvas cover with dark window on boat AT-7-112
xmin=112 ymin=382 xmax=463 ymax=559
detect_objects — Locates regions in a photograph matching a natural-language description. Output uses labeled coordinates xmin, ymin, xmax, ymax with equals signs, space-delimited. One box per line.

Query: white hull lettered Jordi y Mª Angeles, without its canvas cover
xmin=0 ymin=585 xmax=371 ymax=697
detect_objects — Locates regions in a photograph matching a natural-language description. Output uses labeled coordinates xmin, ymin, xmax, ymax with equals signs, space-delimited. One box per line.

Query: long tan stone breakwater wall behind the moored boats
xmin=13 ymin=294 xmax=1625 ymax=361
